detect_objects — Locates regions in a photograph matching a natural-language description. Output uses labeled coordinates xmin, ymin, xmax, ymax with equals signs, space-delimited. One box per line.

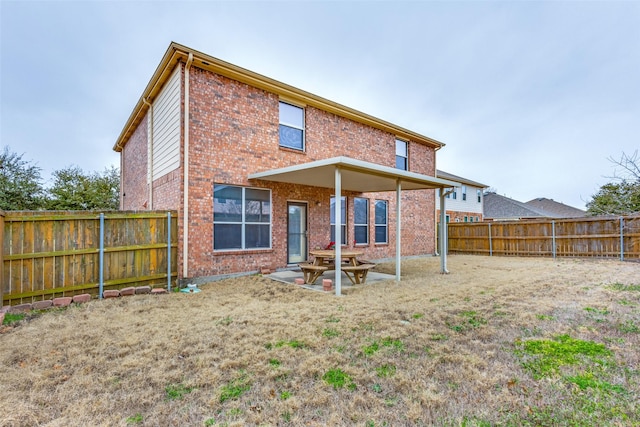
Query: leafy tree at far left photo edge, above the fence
xmin=0 ymin=146 xmax=44 ymax=211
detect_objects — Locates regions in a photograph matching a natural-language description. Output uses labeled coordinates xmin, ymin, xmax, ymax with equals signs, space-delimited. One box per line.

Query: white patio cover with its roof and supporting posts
xmin=248 ymin=156 xmax=461 ymax=295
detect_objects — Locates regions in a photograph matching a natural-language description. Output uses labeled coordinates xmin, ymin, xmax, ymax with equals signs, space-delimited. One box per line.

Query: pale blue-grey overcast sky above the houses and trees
xmin=0 ymin=0 xmax=640 ymax=208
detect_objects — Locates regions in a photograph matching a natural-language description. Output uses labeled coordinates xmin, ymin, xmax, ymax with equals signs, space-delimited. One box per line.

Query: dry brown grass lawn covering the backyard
xmin=0 ymin=256 xmax=640 ymax=426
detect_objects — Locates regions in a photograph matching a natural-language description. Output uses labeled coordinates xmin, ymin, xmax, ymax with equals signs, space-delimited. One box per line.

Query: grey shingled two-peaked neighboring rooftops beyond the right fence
xmin=484 ymin=193 xmax=585 ymax=221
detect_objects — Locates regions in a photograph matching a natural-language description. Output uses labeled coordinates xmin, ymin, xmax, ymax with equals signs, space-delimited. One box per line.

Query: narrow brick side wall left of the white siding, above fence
xmin=120 ymin=114 xmax=149 ymax=210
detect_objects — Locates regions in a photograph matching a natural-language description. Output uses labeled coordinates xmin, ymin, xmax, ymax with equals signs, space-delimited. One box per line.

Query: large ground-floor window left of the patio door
xmin=213 ymin=184 xmax=271 ymax=250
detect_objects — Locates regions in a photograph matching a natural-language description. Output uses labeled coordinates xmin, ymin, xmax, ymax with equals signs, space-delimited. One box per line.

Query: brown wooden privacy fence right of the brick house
xmin=448 ymin=215 xmax=640 ymax=260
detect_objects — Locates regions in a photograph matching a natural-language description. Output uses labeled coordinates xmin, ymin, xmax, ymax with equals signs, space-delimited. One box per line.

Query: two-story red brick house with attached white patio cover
xmin=114 ymin=43 xmax=459 ymax=292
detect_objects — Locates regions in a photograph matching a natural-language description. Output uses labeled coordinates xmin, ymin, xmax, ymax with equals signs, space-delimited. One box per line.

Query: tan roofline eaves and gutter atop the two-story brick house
xmin=113 ymin=42 xmax=445 ymax=152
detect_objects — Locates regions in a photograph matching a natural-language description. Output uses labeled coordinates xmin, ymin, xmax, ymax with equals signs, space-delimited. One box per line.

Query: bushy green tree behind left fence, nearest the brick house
xmin=47 ymin=166 xmax=120 ymax=210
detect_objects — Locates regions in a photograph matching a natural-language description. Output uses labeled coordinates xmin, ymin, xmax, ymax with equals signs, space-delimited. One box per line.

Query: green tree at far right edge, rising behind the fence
xmin=587 ymin=151 xmax=640 ymax=215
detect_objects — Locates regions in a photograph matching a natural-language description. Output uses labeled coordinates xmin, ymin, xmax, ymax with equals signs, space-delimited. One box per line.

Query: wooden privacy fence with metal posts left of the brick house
xmin=0 ymin=211 xmax=178 ymax=305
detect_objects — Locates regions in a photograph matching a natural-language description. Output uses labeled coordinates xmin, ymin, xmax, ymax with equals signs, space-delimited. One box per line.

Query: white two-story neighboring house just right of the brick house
xmin=436 ymin=170 xmax=488 ymax=222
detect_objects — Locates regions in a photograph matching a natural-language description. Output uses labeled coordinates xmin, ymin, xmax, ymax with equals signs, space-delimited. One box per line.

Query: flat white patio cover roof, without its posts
xmin=249 ymin=156 xmax=460 ymax=193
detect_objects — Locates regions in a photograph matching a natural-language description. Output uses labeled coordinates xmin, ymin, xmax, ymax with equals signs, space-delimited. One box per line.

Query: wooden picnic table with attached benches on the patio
xmin=298 ymin=249 xmax=375 ymax=285
